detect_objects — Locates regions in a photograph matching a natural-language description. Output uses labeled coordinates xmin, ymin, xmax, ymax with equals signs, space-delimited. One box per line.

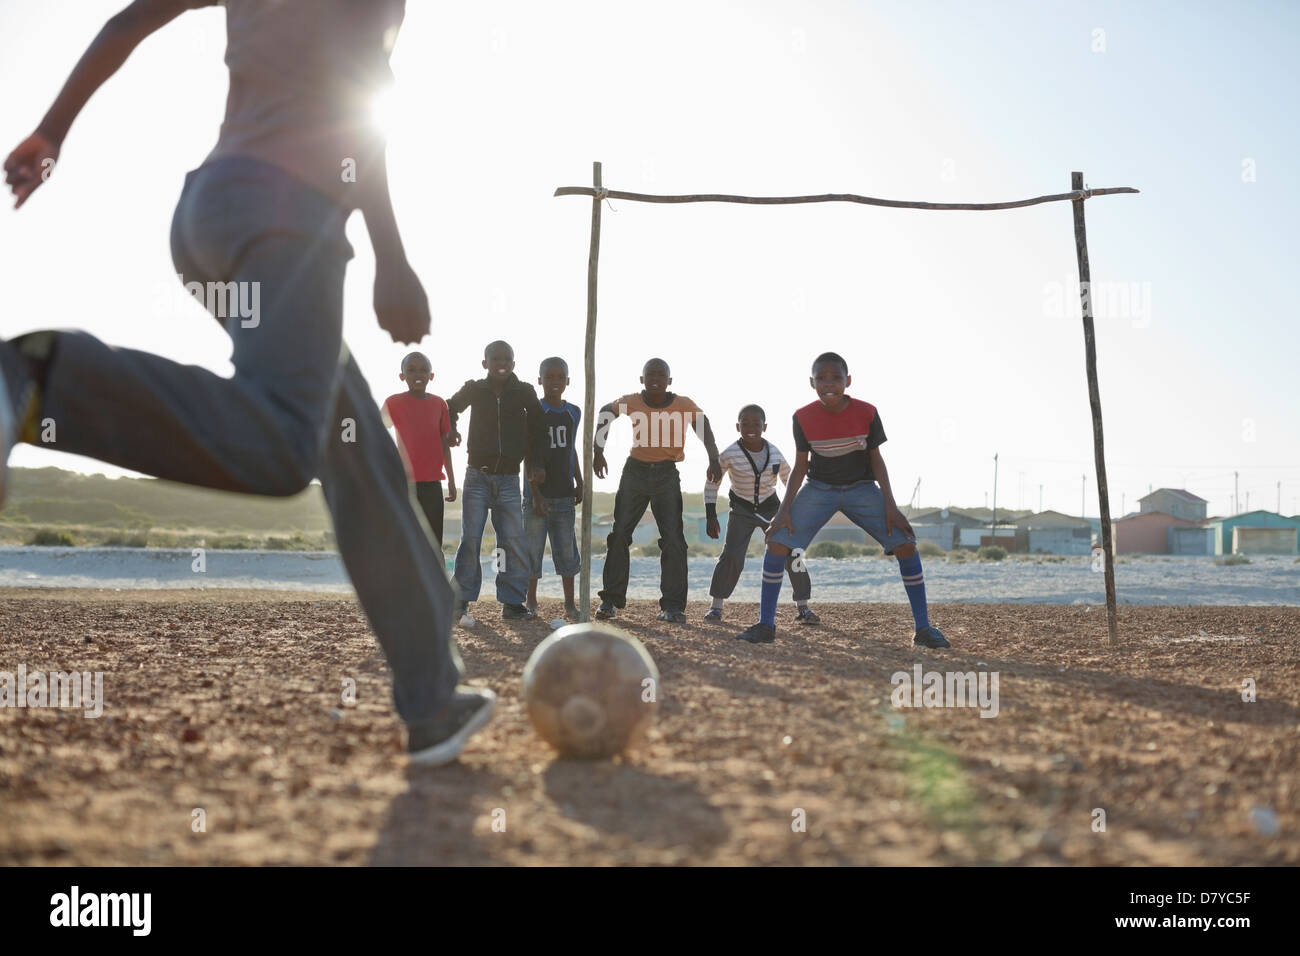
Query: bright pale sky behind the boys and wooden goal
xmin=0 ymin=0 xmax=1300 ymax=515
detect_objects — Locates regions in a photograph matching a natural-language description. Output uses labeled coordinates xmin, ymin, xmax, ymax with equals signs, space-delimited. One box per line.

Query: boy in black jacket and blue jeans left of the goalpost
xmin=447 ymin=341 xmax=546 ymax=620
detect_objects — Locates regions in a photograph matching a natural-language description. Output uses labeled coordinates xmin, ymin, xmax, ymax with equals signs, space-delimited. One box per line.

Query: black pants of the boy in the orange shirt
xmin=601 ymin=458 xmax=686 ymax=611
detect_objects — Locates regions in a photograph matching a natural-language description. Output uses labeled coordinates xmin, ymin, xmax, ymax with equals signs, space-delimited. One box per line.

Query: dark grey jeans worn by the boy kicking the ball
xmin=42 ymin=157 xmax=462 ymax=723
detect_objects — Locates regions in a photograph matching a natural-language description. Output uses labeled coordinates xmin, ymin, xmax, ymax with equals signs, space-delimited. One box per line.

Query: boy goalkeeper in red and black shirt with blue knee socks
xmin=737 ymin=352 xmax=952 ymax=648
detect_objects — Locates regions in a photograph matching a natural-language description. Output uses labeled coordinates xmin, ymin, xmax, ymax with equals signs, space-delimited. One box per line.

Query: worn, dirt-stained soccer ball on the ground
xmin=524 ymin=623 xmax=659 ymax=760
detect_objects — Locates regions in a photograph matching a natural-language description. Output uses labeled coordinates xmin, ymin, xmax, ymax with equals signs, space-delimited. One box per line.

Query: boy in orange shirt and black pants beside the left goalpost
xmin=592 ymin=359 xmax=723 ymax=624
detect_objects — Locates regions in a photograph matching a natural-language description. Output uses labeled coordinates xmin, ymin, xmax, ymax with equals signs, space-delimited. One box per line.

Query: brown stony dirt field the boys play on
xmin=0 ymin=591 xmax=1300 ymax=865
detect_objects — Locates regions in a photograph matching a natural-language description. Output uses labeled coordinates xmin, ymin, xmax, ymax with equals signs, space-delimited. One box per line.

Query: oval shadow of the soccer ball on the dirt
xmin=542 ymin=758 xmax=729 ymax=851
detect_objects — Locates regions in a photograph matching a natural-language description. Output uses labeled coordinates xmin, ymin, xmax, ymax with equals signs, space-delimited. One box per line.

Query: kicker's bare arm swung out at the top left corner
xmin=4 ymin=0 xmax=217 ymax=208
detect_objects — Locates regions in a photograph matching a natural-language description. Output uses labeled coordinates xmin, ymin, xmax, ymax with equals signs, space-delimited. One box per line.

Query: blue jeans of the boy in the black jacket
xmin=454 ymin=468 xmax=529 ymax=604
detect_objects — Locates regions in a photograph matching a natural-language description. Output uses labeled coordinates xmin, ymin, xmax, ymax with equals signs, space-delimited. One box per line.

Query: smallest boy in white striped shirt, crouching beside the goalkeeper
xmin=705 ymin=405 xmax=820 ymax=624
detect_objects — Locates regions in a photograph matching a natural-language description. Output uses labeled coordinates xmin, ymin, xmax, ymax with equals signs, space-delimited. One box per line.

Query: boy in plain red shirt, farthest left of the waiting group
xmin=380 ymin=352 xmax=456 ymax=548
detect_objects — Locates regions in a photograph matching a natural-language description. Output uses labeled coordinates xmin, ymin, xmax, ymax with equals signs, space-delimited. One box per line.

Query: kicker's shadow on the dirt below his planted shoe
xmin=367 ymin=763 xmax=508 ymax=866
